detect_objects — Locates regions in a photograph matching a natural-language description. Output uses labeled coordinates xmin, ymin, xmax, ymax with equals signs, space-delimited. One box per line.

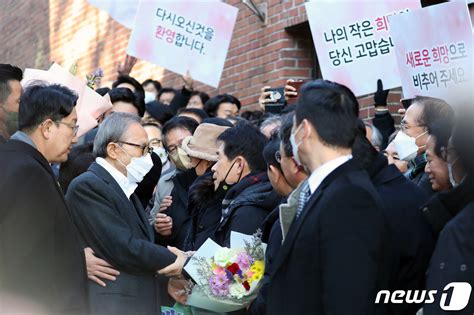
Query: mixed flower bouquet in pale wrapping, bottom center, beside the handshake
xmin=185 ymin=232 xmax=266 ymax=312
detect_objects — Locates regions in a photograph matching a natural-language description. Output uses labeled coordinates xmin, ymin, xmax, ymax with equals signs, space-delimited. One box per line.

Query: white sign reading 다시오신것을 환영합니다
xmin=127 ymin=0 xmax=238 ymax=87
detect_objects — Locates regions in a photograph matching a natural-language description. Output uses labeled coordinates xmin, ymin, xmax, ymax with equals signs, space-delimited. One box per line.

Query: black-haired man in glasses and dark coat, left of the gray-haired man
xmin=0 ymin=85 xmax=89 ymax=314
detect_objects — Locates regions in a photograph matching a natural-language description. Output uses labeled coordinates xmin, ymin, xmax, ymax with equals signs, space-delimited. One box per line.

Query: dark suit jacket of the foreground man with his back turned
xmin=267 ymin=160 xmax=389 ymax=315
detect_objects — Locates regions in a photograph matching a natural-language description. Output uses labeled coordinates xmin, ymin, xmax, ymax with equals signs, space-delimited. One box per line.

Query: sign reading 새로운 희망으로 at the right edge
xmin=390 ymin=2 xmax=474 ymax=105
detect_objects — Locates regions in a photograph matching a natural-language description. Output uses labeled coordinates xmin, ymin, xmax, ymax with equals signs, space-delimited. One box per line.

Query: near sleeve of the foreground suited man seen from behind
xmin=319 ymin=186 xmax=386 ymax=315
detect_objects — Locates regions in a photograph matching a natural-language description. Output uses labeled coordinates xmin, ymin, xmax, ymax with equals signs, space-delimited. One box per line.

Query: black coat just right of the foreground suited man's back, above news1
xmin=370 ymin=154 xmax=435 ymax=315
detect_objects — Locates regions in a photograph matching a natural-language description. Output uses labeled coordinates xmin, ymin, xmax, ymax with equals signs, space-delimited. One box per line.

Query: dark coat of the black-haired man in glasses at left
xmin=0 ymin=140 xmax=89 ymax=314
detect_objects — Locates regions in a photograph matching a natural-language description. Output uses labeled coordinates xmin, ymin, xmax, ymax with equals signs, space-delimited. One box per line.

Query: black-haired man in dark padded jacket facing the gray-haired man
xmin=212 ymin=123 xmax=281 ymax=247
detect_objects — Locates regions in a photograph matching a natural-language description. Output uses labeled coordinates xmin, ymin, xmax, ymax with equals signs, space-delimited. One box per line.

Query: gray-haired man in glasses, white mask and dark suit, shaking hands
xmin=66 ymin=113 xmax=185 ymax=314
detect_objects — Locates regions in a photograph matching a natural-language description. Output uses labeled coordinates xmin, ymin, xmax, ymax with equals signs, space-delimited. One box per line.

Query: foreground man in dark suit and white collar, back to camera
xmin=267 ymin=80 xmax=390 ymax=315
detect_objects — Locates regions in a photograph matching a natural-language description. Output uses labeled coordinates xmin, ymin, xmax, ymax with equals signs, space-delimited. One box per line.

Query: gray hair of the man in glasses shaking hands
xmin=93 ymin=113 xmax=140 ymax=158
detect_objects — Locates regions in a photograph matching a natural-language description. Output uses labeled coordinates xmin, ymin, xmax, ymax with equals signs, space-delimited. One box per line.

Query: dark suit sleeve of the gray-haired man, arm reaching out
xmin=66 ymin=181 xmax=176 ymax=272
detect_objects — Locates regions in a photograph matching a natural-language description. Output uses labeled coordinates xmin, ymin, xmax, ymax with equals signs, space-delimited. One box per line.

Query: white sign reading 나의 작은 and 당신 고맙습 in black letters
xmin=306 ymin=0 xmax=420 ymax=96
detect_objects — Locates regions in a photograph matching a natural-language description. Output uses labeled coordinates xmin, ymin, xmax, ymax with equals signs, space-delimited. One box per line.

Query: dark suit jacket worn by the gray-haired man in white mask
xmin=66 ymin=163 xmax=176 ymax=315
